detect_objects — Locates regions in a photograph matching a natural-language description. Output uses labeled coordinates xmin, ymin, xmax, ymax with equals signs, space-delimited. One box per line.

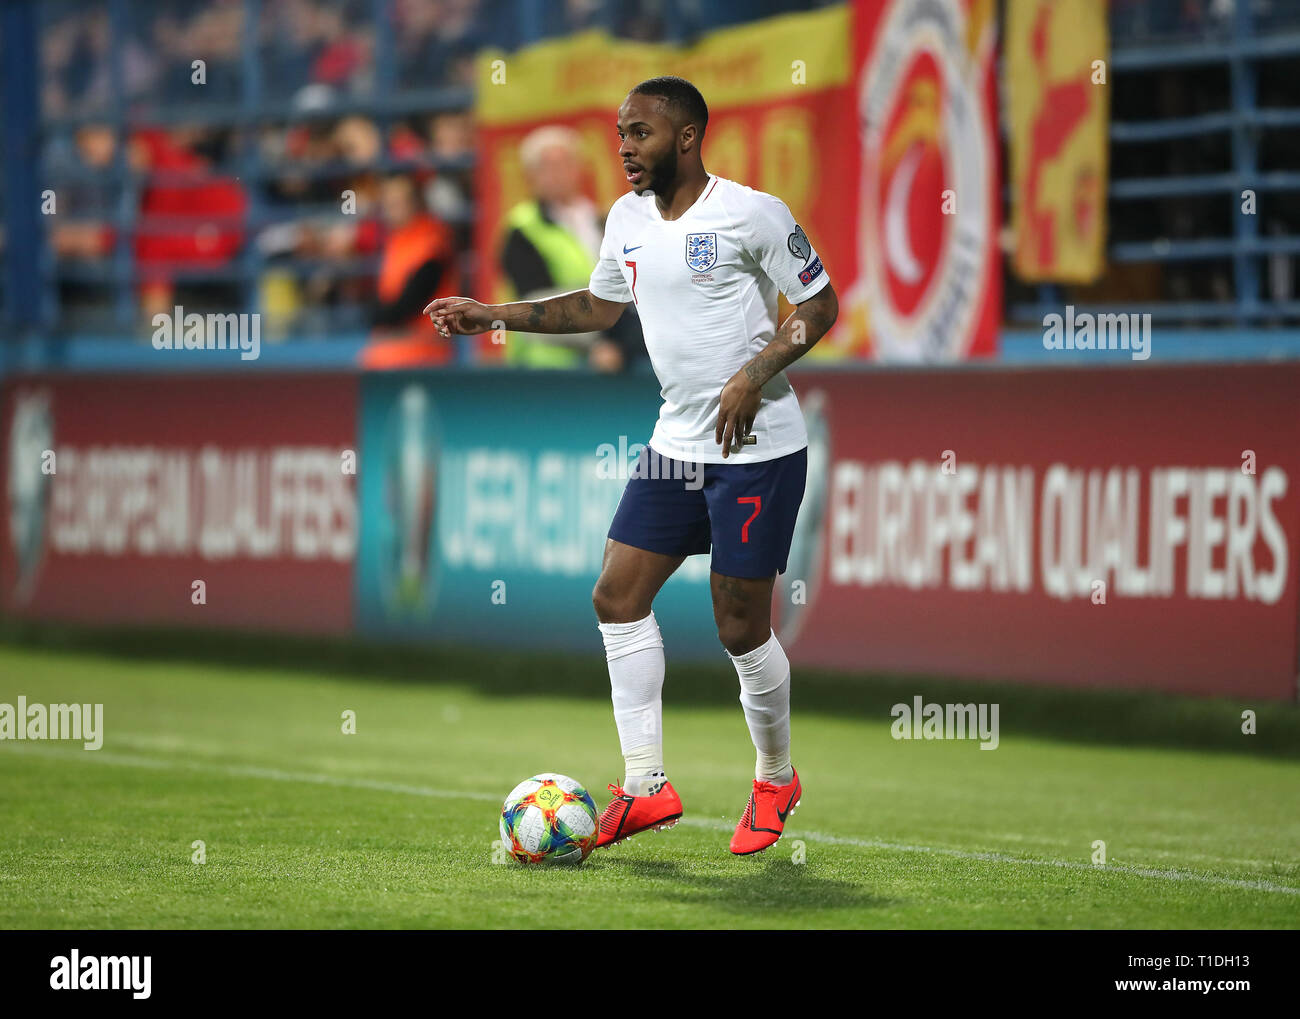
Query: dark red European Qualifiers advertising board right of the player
xmin=783 ymin=364 xmax=1300 ymax=699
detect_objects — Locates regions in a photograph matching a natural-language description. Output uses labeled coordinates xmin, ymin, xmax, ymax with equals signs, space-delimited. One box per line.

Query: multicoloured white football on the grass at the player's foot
xmin=501 ymin=772 xmax=597 ymax=863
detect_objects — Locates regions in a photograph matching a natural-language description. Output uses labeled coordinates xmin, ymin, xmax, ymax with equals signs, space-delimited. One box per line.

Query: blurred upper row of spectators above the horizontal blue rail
xmin=42 ymin=0 xmax=491 ymax=117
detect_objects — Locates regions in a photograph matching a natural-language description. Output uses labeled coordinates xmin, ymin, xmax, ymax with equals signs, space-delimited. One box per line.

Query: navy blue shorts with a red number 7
xmin=610 ymin=446 xmax=809 ymax=577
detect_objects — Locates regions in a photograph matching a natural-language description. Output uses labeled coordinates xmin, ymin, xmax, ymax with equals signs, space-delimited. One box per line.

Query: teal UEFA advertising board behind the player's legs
xmin=356 ymin=372 xmax=722 ymax=656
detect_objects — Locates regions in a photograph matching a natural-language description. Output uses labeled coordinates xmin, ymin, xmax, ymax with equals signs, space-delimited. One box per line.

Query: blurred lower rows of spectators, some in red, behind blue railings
xmin=46 ymin=112 xmax=483 ymax=337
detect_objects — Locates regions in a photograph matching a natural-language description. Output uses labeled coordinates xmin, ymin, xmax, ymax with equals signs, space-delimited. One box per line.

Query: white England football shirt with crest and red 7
xmin=590 ymin=174 xmax=829 ymax=464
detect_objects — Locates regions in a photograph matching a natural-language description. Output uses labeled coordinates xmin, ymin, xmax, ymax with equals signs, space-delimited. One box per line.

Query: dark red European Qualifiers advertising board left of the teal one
xmin=0 ymin=374 xmax=358 ymax=633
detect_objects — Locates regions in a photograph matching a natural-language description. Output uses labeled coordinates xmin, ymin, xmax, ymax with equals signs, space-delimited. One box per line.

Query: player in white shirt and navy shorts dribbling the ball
xmin=425 ymin=77 xmax=839 ymax=855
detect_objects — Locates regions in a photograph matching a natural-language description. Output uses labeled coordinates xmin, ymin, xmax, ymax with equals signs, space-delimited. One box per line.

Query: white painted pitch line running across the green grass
xmin=0 ymin=741 xmax=1300 ymax=896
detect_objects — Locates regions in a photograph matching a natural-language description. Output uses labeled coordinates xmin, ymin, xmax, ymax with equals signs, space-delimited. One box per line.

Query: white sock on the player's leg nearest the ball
xmin=597 ymin=612 xmax=664 ymax=795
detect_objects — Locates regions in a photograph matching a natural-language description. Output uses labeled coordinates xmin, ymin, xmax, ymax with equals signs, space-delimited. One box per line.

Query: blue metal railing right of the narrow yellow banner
xmin=1008 ymin=0 xmax=1300 ymax=328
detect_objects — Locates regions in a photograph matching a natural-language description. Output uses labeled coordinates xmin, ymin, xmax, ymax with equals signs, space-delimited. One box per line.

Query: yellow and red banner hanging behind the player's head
xmin=475 ymin=5 xmax=854 ymax=356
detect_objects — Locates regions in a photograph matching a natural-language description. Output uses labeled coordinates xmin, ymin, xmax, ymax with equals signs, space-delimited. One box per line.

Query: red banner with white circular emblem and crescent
xmin=835 ymin=0 xmax=1002 ymax=363
